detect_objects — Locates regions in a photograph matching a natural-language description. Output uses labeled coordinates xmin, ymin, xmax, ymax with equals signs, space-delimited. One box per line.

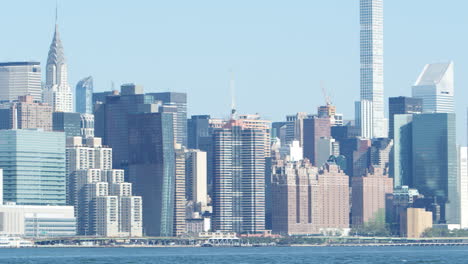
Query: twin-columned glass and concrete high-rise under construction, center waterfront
xmin=213 ymin=119 xmax=269 ymax=233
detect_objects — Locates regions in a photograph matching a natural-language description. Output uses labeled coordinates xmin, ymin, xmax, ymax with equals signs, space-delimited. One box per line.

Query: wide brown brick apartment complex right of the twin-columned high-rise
xmin=271 ymin=159 xmax=350 ymax=235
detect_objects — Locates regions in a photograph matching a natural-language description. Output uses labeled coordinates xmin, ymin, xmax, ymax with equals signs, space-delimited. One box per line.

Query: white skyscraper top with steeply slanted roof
xmin=412 ymin=62 xmax=455 ymax=113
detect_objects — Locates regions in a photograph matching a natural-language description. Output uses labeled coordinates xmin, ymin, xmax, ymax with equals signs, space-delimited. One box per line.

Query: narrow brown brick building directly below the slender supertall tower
xmin=351 ymin=167 xmax=393 ymax=227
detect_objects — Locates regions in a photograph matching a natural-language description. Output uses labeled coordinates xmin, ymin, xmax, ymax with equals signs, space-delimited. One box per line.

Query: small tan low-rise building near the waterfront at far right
xmin=400 ymin=208 xmax=432 ymax=238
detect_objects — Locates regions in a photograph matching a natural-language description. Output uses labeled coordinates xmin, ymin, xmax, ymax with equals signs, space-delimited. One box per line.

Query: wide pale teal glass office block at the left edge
xmin=0 ymin=129 xmax=66 ymax=205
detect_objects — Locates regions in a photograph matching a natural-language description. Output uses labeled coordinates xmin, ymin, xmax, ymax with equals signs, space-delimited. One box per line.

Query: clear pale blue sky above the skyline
xmin=0 ymin=0 xmax=468 ymax=144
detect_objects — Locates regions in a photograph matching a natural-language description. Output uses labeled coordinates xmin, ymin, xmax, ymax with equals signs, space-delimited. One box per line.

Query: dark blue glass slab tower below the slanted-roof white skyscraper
xmin=410 ymin=113 xmax=460 ymax=224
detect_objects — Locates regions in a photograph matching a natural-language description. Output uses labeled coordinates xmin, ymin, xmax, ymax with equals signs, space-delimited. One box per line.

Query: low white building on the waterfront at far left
xmin=0 ymin=203 xmax=76 ymax=238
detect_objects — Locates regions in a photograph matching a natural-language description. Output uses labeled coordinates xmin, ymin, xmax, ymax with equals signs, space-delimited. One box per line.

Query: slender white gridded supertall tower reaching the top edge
xmin=359 ymin=0 xmax=387 ymax=138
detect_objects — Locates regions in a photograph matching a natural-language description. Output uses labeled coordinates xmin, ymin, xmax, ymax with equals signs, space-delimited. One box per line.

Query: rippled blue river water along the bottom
xmin=0 ymin=246 xmax=468 ymax=264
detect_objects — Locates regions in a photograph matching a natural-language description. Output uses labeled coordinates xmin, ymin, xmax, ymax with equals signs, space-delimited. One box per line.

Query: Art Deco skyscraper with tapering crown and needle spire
xmin=43 ymin=8 xmax=73 ymax=112
